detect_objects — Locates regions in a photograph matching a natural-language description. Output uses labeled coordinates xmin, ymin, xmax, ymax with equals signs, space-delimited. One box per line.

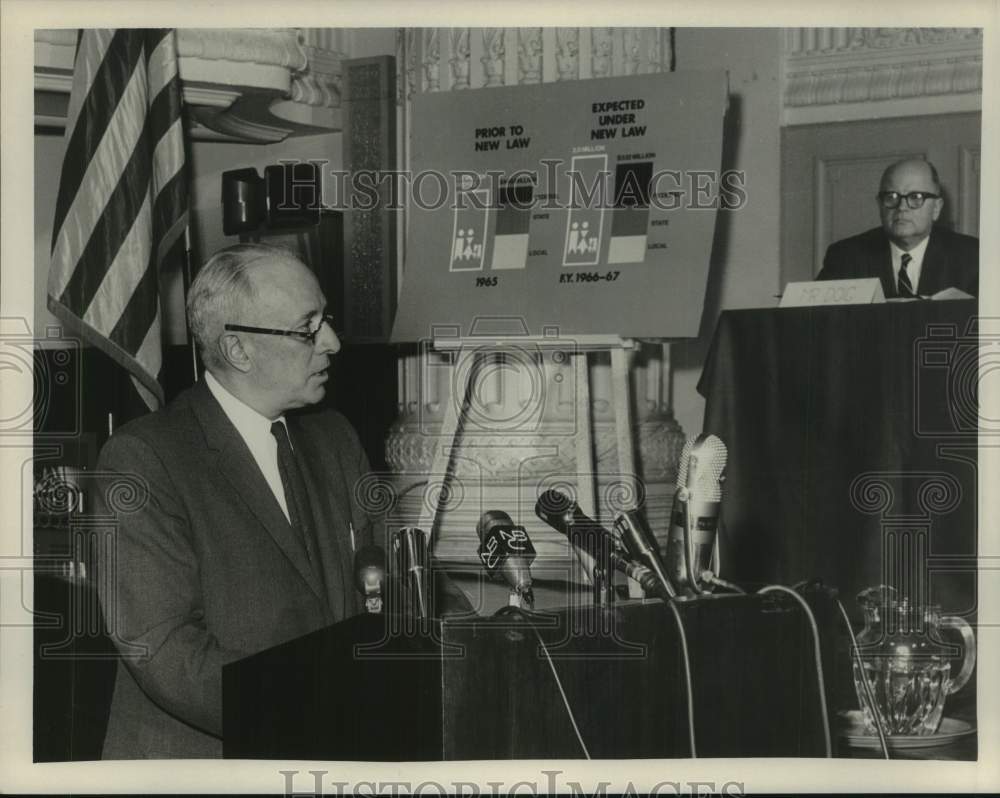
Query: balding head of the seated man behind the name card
xmin=879 ymin=158 xmax=944 ymax=251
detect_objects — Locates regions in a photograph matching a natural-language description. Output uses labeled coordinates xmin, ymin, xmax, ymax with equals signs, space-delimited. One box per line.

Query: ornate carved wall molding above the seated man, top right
xmin=783 ymin=28 xmax=983 ymax=124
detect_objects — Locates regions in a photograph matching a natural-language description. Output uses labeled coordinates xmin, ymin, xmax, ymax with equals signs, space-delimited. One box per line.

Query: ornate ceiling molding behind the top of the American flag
xmin=35 ymin=28 xmax=344 ymax=143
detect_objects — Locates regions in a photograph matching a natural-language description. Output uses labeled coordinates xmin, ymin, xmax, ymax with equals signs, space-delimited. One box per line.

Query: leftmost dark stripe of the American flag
xmin=52 ymin=30 xmax=142 ymax=245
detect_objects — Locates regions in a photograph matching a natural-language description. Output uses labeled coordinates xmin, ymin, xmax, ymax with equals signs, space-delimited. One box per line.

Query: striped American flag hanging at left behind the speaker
xmin=48 ymin=29 xmax=188 ymax=409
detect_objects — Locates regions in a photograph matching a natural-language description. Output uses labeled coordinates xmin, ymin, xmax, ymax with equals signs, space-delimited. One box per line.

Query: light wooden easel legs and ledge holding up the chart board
xmin=420 ymin=335 xmax=639 ymax=592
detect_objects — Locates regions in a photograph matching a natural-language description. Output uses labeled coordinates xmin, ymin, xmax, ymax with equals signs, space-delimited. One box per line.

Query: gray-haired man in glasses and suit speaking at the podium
xmin=98 ymin=244 xmax=372 ymax=759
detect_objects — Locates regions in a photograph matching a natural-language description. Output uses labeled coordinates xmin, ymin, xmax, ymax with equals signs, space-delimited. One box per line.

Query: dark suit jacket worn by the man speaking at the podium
xmin=98 ymin=382 xmax=372 ymax=759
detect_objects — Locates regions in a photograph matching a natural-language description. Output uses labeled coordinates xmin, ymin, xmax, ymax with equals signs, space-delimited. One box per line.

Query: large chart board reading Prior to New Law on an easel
xmin=393 ymin=71 xmax=732 ymax=342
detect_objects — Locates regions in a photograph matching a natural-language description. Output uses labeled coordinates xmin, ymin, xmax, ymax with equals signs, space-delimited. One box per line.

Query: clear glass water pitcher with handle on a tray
xmin=853 ymin=585 xmax=976 ymax=735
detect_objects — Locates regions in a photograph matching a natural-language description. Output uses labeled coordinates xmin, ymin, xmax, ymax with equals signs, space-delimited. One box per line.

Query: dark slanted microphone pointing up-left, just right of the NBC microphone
xmin=535 ymin=490 xmax=660 ymax=598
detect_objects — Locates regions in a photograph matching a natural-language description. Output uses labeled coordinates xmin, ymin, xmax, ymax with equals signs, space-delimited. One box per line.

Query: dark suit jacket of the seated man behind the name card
xmin=816 ymin=227 xmax=979 ymax=297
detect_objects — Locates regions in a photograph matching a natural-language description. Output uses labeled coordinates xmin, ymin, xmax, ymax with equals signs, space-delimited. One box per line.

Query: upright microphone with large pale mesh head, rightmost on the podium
xmin=667 ymin=434 xmax=728 ymax=594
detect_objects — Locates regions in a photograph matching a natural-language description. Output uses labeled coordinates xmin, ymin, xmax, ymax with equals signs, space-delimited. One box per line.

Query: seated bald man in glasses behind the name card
xmin=817 ymin=159 xmax=979 ymax=298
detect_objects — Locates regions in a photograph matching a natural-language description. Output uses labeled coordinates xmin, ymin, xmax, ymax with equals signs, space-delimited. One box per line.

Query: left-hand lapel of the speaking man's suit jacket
xmin=191 ymin=380 xmax=325 ymax=604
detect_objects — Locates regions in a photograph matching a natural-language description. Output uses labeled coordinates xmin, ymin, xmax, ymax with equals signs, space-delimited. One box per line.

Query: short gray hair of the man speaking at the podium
xmin=187 ymin=244 xmax=299 ymax=371
